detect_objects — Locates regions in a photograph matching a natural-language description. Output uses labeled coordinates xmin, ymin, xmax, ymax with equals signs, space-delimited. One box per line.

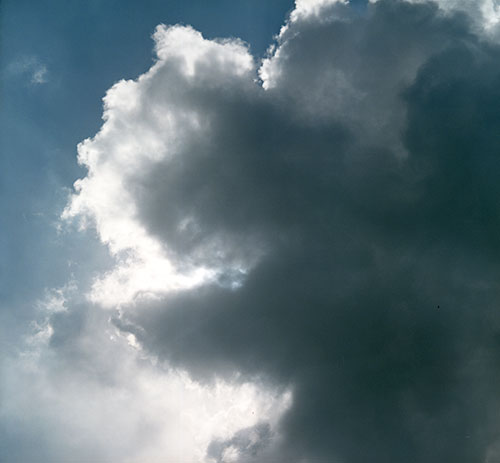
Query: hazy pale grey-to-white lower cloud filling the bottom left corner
xmin=0 ymin=285 xmax=291 ymax=463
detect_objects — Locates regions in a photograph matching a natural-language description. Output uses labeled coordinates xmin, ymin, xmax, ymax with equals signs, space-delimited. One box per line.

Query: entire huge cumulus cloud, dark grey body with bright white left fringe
xmin=4 ymin=0 xmax=500 ymax=463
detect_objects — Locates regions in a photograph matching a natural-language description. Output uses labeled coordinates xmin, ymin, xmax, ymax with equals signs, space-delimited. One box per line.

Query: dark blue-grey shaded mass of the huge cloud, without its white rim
xmin=105 ymin=1 xmax=500 ymax=463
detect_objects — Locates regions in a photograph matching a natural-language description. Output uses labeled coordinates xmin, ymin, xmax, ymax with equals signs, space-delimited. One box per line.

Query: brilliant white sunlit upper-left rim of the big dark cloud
xmin=63 ymin=25 xmax=254 ymax=306
